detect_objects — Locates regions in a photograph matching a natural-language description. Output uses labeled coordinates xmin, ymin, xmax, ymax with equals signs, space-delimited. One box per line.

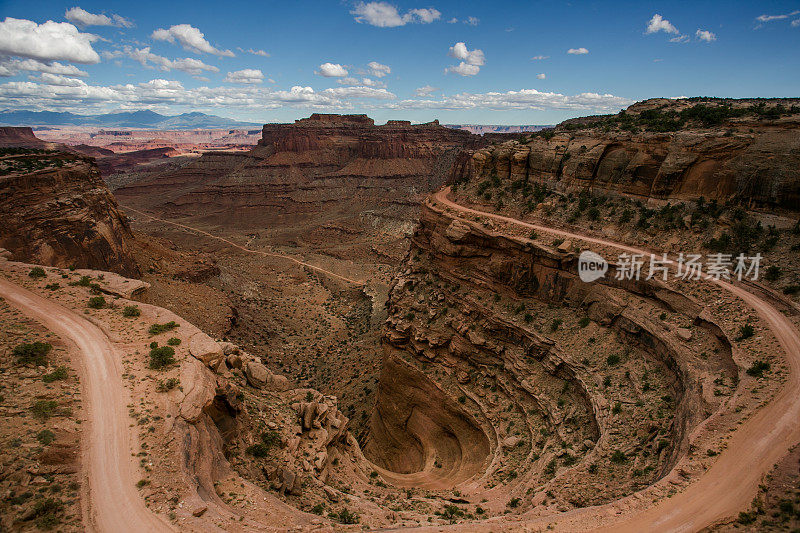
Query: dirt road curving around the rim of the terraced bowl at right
xmin=433 ymin=187 xmax=800 ymax=533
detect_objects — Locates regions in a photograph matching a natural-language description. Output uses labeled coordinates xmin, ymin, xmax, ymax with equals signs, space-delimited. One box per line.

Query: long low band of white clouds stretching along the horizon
xmin=0 ymin=76 xmax=633 ymax=114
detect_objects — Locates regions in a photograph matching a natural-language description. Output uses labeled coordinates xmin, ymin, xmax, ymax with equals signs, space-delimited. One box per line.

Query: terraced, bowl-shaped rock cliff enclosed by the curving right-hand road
xmin=362 ymin=199 xmax=737 ymax=508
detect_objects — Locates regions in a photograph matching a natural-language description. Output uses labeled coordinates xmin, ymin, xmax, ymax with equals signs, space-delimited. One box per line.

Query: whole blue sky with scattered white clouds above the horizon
xmin=0 ymin=0 xmax=800 ymax=124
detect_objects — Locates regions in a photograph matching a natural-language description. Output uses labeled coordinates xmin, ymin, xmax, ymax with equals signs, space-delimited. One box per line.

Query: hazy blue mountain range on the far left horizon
xmin=0 ymin=110 xmax=263 ymax=130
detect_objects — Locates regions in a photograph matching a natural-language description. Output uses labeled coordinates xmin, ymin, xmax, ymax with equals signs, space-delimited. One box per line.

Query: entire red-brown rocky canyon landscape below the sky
xmin=0 ymin=99 xmax=800 ymax=531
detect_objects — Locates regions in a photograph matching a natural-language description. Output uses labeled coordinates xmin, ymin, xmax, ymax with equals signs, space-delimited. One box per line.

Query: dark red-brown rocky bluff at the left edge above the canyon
xmin=0 ymin=150 xmax=139 ymax=276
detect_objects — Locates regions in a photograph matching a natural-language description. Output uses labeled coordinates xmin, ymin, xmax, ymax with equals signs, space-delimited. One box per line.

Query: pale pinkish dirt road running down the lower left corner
xmin=0 ymin=278 xmax=173 ymax=533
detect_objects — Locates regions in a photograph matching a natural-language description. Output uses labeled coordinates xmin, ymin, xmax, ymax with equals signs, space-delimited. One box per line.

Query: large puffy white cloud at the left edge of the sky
xmin=0 ymin=17 xmax=100 ymax=63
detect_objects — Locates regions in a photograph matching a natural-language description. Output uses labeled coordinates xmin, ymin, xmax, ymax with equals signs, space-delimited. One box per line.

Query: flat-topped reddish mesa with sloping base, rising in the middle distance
xmin=116 ymin=114 xmax=483 ymax=224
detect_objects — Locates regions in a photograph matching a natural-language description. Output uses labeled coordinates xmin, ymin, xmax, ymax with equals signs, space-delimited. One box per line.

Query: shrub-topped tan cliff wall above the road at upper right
xmin=454 ymin=100 xmax=800 ymax=211
